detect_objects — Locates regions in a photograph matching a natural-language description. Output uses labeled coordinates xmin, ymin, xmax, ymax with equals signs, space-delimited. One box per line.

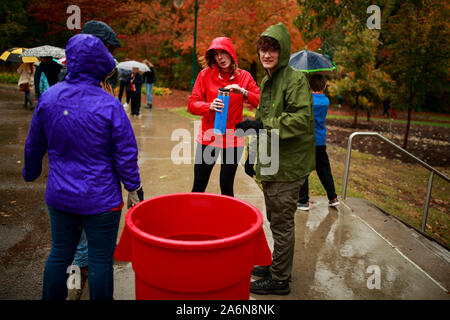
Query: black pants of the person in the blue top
xmin=298 ymin=146 xmax=337 ymax=203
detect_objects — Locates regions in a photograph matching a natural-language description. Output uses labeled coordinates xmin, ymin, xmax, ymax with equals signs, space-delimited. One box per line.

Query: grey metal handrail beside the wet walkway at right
xmin=342 ymin=132 xmax=450 ymax=232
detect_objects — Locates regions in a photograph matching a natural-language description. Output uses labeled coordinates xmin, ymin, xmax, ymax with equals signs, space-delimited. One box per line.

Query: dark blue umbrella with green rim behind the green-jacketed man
xmin=289 ymin=50 xmax=337 ymax=73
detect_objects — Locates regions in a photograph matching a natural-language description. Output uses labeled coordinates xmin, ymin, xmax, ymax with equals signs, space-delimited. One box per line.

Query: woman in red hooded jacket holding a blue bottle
xmin=188 ymin=37 xmax=259 ymax=196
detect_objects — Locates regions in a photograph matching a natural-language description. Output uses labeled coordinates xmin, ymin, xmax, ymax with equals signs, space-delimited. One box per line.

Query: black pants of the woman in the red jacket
xmin=192 ymin=144 xmax=244 ymax=197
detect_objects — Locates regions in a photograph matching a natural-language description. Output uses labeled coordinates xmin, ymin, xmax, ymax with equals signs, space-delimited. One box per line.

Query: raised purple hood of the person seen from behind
xmin=66 ymin=34 xmax=115 ymax=85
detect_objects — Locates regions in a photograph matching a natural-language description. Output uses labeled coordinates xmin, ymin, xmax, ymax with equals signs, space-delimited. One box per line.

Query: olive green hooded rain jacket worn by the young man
xmin=255 ymin=23 xmax=316 ymax=182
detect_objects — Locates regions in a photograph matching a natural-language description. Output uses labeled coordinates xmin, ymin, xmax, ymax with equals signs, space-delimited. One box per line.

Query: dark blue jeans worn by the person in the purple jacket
xmin=42 ymin=206 xmax=121 ymax=300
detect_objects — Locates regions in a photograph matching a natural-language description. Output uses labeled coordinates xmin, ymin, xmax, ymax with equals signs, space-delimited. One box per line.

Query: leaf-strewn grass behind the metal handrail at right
xmin=310 ymin=145 xmax=450 ymax=247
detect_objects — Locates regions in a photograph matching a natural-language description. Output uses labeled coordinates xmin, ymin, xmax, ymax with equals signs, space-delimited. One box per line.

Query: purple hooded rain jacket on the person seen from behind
xmin=23 ymin=34 xmax=141 ymax=215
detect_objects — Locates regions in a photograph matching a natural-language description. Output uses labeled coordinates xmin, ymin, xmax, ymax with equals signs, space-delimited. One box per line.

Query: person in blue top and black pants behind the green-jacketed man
xmin=297 ymin=74 xmax=339 ymax=211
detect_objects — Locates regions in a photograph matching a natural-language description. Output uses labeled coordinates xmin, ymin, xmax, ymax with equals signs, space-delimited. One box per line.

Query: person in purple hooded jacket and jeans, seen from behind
xmin=23 ymin=34 xmax=143 ymax=300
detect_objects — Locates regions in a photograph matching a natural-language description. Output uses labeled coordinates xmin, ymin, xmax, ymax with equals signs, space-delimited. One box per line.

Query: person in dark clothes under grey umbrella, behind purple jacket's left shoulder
xmin=34 ymin=57 xmax=62 ymax=99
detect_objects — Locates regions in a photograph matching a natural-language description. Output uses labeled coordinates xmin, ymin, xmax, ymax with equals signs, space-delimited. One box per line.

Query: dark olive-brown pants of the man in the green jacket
xmin=262 ymin=178 xmax=305 ymax=280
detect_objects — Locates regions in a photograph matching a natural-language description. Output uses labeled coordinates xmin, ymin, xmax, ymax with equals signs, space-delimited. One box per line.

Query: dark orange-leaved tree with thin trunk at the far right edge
xmin=385 ymin=0 xmax=450 ymax=148
